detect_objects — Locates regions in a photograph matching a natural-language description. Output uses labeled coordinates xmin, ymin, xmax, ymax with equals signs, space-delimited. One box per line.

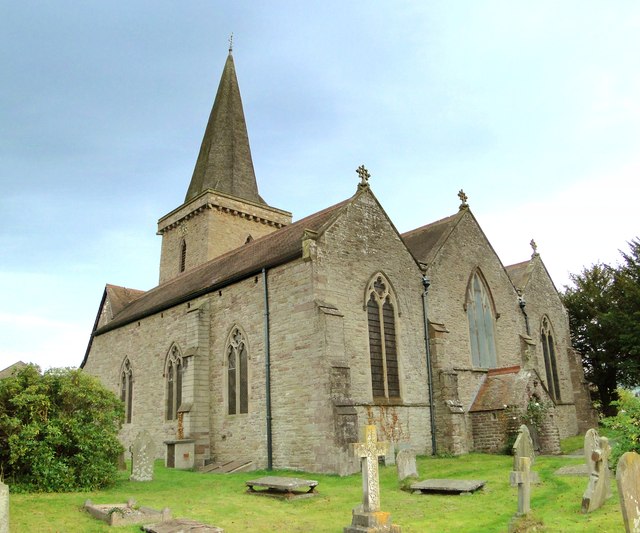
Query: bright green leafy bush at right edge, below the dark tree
xmin=602 ymin=389 xmax=640 ymax=465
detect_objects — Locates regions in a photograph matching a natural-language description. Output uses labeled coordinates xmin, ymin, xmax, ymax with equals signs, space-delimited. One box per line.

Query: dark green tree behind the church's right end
xmin=562 ymin=239 xmax=640 ymax=416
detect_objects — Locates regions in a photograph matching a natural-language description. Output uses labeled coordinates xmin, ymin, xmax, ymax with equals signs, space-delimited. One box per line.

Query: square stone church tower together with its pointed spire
xmin=158 ymin=49 xmax=291 ymax=284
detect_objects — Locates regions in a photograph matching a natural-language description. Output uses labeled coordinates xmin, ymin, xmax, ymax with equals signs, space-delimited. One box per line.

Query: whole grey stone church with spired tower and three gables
xmin=81 ymin=51 xmax=593 ymax=474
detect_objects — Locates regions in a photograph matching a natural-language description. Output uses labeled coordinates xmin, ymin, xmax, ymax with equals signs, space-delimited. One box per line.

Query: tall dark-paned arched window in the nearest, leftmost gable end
xmin=366 ymin=274 xmax=400 ymax=399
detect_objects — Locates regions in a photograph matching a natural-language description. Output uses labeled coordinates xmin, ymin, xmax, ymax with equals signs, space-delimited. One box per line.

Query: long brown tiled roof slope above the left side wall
xmin=95 ymin=194 xmax=350 ymax=335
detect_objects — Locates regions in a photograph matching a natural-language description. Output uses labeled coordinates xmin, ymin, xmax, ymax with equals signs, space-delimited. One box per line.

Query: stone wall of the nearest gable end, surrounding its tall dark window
xmin=314 ymin=193 xmax=431 ymax=453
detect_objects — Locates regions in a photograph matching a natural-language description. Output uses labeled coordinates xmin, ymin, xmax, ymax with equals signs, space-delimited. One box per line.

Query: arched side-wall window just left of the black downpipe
xmin=226 ymin=327 xmax=249 ymax=415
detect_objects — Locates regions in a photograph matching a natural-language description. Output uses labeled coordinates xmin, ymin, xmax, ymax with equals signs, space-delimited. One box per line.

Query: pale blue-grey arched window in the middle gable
xmin=465 ymin=270 xmax=497 ymax=368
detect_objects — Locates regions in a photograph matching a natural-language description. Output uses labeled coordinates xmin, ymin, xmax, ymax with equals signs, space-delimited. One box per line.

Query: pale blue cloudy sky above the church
xmin=0 ymin=0 xmax=640 ymax=369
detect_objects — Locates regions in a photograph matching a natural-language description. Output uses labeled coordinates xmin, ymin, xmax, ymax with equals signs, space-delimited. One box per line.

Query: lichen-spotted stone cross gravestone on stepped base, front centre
xmin=344 ymin=426 xmax=401 ymax=533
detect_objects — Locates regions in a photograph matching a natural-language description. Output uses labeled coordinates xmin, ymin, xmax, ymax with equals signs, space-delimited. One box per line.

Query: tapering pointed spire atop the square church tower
xmin=185 ymin=50 xmax=265 ymax=204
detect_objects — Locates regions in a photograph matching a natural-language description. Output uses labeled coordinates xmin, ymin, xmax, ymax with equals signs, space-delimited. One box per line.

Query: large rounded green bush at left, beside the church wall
xmin=0 ymin=365 xmax=123 ymax=492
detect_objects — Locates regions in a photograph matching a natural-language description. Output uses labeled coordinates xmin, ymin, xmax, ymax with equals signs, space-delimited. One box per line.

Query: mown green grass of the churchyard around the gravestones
xmin=10 ymin=448 xmax=624 ymax=533
